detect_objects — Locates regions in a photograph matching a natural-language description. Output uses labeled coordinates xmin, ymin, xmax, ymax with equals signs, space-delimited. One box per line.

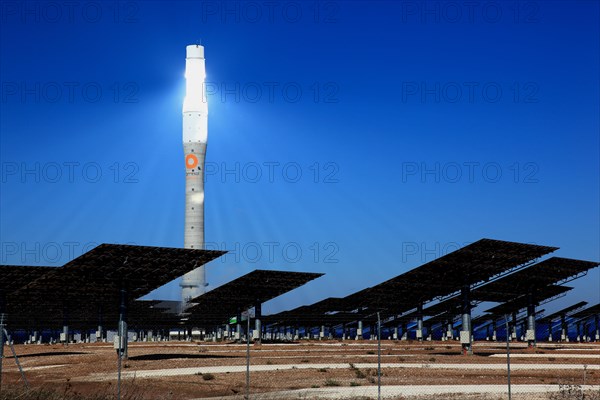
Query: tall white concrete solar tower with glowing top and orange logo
xmin=180 ymin=45 xmax=208 ymax=307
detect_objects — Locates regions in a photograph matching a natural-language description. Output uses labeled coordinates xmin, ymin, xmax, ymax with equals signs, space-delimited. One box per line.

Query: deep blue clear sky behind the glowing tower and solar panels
xmin=0 ymin=0 xmax=600 ymax=318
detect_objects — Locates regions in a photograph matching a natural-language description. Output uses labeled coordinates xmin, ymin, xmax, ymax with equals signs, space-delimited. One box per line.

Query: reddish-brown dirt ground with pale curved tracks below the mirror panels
xmin=2 ymin=340 xmax=600 ymax=400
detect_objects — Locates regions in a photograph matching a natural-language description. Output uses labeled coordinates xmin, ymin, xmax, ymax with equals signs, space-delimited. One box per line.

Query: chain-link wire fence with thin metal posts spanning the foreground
xmin=0 ymin=314 xmax=600 ymax=400
